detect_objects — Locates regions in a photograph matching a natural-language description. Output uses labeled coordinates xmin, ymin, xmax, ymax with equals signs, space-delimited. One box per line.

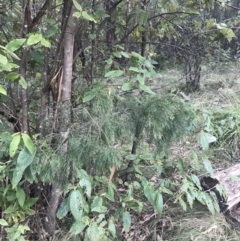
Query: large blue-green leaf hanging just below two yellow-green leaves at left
xmin=12 ymin=148 xmax=36 ymax=188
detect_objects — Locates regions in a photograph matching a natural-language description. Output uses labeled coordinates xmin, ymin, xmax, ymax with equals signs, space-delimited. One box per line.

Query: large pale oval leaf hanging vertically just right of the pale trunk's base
xmin=69 ymin=190 xmax=84 ymax=220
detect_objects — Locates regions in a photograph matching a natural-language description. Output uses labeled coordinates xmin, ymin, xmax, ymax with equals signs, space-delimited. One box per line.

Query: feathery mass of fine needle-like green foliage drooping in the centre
xmin=66 ymin=83 xmax=193 ymax=177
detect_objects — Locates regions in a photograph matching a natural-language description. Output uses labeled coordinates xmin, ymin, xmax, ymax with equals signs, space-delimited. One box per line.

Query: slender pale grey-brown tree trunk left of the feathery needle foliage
xmin=45 ymin=0 xmax=76 ymax=234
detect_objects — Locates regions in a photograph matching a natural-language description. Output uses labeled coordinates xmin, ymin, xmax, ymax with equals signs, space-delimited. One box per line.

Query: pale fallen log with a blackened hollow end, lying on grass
xmin=200 ymin=164 xmax=240 ymax=229
